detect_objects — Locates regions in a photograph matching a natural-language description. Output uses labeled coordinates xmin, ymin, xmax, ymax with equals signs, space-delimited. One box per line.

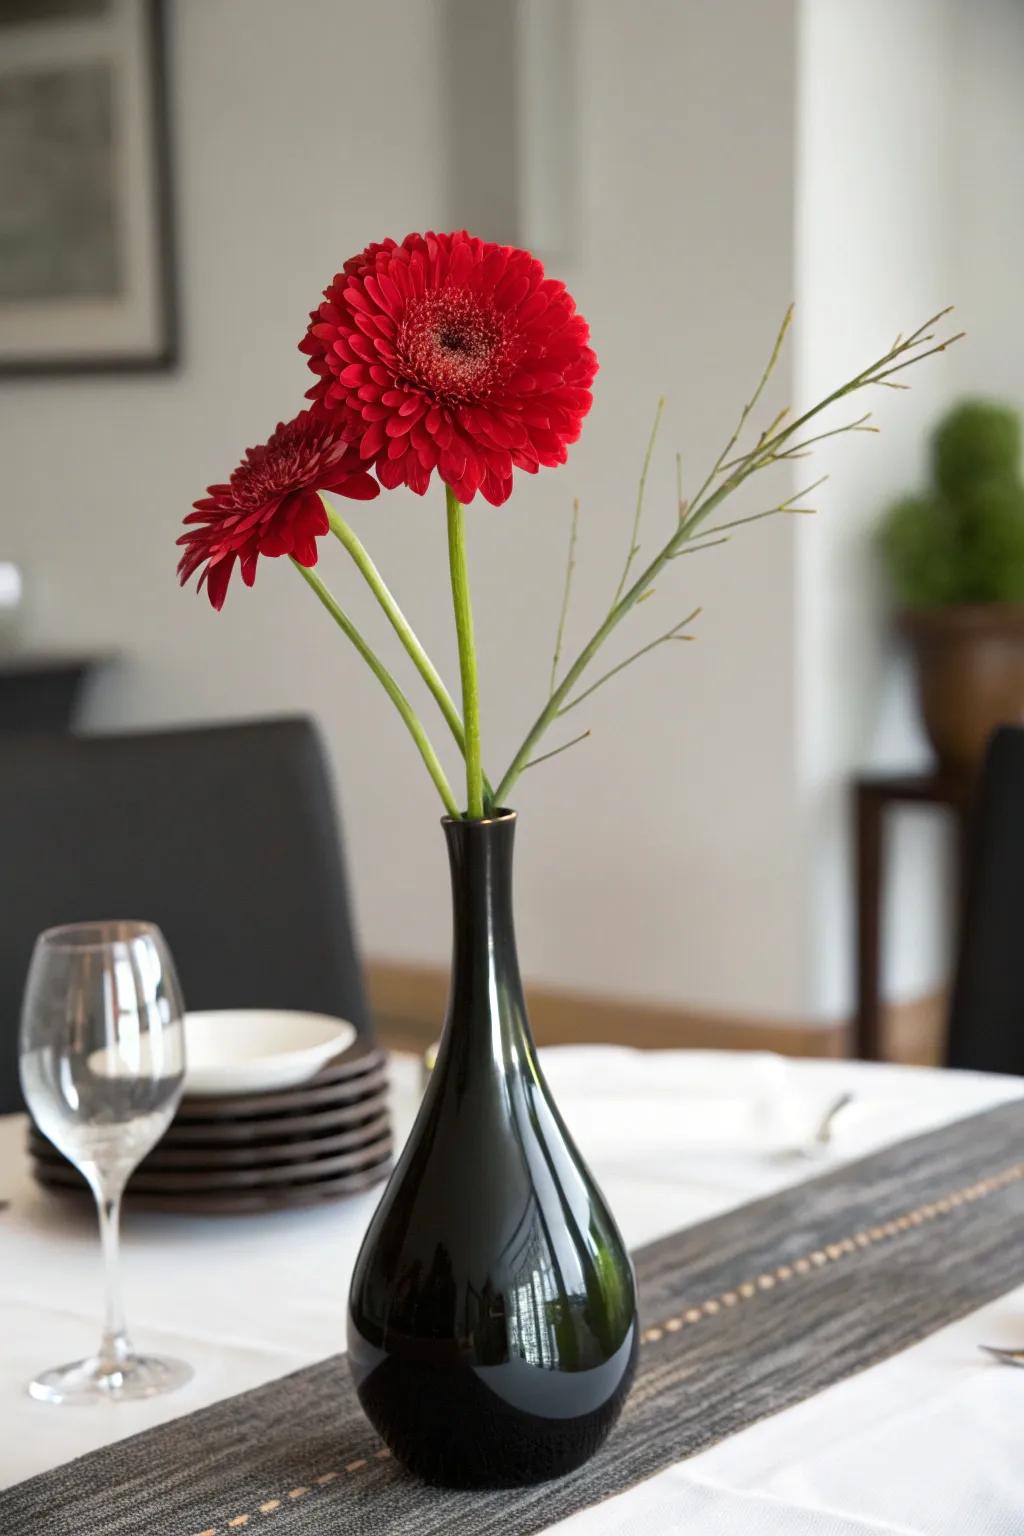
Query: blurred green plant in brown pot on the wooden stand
xmin=880 ymin=399 xmax=1024 ymax=777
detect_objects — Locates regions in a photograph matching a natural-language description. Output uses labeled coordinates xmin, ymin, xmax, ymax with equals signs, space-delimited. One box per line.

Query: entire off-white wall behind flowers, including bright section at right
xmin=0 ymin=0 xmax=1024 ymax=1018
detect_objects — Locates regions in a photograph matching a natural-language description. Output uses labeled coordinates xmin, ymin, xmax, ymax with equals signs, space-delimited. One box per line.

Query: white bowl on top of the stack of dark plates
xmin=184 ymin=1008 xmax=356 ymax=1097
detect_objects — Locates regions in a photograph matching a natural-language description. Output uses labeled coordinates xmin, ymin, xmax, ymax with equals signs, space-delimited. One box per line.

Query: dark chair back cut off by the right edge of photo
xmin=946 ymin=725 xmax=1024 ymax=1074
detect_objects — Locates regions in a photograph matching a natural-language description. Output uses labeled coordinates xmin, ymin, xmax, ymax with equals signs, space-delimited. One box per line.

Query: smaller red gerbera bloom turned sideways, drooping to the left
xmin=178 ymin=410 xmax=381 ymax=608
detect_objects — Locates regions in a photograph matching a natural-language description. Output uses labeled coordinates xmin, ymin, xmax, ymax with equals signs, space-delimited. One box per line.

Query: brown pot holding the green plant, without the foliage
xmin=900 ymin=604 xmax=1024 ymax=777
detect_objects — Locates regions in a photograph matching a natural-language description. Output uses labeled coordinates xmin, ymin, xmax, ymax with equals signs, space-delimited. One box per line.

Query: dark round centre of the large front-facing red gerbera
xmin=398 ymin=289 xmax=519 ymax=401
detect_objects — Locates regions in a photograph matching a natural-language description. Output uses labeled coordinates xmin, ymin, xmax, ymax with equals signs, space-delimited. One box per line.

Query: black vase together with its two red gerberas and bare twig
xmin=180 ymin=230 xmax=955 ymax=1487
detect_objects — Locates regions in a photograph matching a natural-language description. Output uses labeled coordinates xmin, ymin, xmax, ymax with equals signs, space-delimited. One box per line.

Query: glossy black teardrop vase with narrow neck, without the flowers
xmin=348 ymin=811 xmax=637 ymax=1488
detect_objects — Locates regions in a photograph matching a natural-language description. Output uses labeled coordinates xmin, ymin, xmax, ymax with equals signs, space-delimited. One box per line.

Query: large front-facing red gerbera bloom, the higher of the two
xmin=299 ymin=230 xmax=597 ymax=505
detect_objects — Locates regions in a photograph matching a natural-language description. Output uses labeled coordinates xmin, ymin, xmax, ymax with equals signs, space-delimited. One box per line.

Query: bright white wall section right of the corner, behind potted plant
xmin=795 ymin=0 xmax=1024 ymax=1018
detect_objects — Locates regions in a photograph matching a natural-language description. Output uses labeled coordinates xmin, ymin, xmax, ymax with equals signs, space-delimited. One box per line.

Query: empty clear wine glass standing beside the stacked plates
xmin=20 ymin=922 xmax=192 ymax=1404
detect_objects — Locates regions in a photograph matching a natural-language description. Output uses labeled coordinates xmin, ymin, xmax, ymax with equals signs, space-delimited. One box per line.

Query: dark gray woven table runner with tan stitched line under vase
xmin=8 ymin=1103 xmax=1024 ymax=1536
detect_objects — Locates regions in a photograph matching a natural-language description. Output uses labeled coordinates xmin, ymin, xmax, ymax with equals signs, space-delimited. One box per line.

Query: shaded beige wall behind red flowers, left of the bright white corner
xmin=0 ymin=0 xmax=801 ymax=1015
